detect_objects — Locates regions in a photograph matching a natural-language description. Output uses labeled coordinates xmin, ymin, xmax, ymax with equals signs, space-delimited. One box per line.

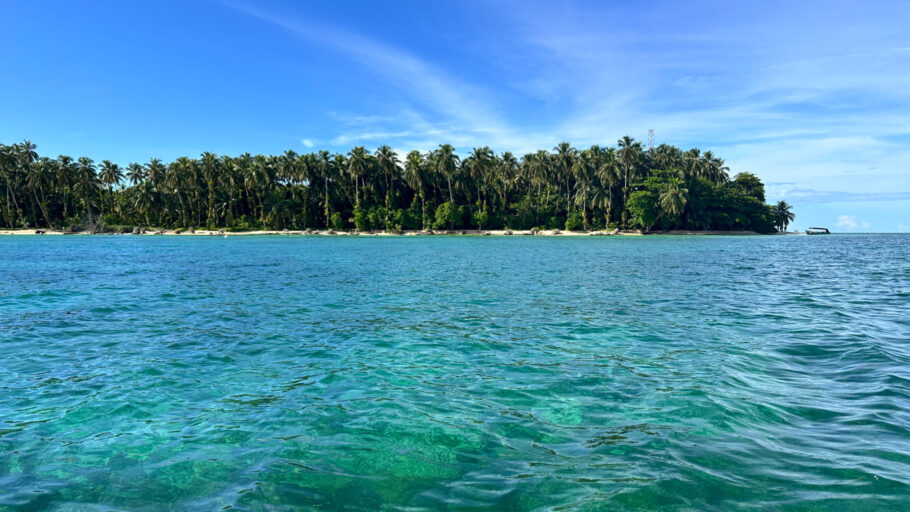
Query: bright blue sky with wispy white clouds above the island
xmin=0 ymin=0 xmax=910 ymax=231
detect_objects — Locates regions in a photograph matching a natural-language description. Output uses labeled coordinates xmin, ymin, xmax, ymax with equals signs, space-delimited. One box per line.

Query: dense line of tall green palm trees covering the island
xmin=0 ymin=136 xmax=793 ymax=233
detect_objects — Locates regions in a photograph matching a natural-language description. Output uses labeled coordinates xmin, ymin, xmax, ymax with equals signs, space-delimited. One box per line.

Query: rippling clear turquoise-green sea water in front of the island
xmin=0 ymin=235 xmax=910 ymax=511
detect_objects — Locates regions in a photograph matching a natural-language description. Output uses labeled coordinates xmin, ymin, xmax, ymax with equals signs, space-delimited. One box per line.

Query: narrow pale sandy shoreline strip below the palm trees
xmin=0 ymin=229 xmax=801 ymax=237
